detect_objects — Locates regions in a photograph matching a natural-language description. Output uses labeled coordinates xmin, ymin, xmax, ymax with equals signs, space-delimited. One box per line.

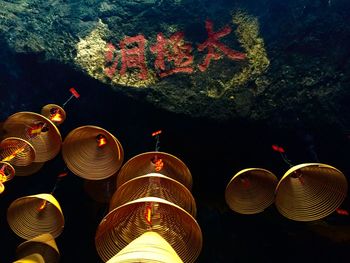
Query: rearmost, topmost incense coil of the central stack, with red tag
xmin=117 ymin=152 xmax=192 ymax=190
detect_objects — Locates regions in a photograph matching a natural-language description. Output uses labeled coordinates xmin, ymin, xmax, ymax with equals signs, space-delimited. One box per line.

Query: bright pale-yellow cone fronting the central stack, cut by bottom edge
xmin=107 ymin=231 xmax=183 ymax=263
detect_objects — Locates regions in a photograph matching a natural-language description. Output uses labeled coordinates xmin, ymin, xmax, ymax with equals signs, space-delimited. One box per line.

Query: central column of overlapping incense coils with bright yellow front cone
xmin=95 ymin=152 xmax=202 ymax=263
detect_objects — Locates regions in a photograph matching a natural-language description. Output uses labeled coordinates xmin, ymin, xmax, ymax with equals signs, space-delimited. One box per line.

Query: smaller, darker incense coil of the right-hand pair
xmin=225 ymin=168 xmax=278 ymax=214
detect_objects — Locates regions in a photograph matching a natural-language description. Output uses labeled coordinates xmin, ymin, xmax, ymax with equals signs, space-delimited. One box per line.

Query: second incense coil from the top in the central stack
xmin=109 ymin=173 xmax=196 ymax=217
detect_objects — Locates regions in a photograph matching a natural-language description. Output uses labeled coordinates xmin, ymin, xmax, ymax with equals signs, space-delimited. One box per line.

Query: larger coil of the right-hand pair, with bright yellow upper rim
xmin=275 ymin=163 xmax=348 ymax=221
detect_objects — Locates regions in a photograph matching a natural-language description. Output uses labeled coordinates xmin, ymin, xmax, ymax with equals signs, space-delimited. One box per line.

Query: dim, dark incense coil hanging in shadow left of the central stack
xmin=84 ymin=175 xmax=116 ymax=203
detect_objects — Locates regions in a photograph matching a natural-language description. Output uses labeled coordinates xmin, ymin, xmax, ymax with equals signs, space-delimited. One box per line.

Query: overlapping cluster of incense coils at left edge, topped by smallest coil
xmin=0 ymin=104 xmax=66 ymax=193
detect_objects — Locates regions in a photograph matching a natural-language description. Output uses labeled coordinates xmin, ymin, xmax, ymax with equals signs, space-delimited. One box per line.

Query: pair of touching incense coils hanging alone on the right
xmin=225 ymin=163 xmax=348 ymax=221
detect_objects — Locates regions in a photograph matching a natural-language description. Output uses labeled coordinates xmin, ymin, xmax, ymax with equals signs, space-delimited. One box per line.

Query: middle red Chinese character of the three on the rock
xmin=150 ymin=32 xmax=193 ymax=77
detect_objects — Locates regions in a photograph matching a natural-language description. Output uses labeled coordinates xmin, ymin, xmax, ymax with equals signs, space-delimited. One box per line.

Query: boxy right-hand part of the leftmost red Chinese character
xmin=120 ymin=35 xmax=147 ymax=79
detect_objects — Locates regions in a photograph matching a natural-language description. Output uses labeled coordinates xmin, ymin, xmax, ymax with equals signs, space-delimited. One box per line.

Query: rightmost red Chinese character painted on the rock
xmin=198 ymin=20 xmax=246 ymax=71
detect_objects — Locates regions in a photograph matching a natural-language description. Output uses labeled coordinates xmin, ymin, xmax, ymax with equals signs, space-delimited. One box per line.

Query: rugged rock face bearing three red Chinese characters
xmin=0 ymin=0 xmax=350 ymax=123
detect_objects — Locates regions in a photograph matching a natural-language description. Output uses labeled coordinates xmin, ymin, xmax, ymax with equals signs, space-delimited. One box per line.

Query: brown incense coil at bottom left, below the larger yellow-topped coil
xmin=16 ymin=234 xmax=60 ymax=263
